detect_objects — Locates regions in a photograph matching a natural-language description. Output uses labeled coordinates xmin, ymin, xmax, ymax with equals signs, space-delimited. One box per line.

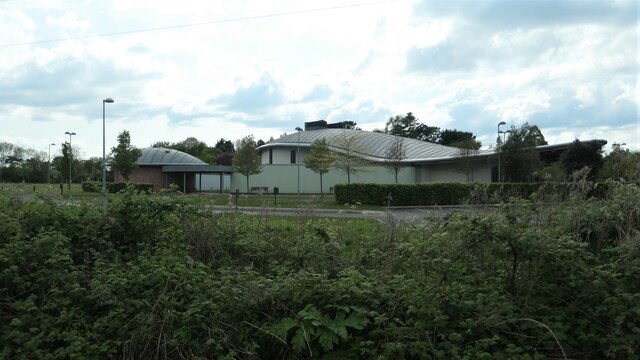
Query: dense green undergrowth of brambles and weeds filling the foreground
xmin=0 ymin=184 xmax=640 ymax=359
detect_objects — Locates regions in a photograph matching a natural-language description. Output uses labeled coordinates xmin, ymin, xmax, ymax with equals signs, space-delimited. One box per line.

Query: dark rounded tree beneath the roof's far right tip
xmin=560 ymin=139 xmax=604 ymax=180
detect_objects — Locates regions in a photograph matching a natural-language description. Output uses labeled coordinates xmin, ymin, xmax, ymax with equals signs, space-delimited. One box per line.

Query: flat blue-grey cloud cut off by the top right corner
xmin=415 ymin=0 xmax=638 ymax=28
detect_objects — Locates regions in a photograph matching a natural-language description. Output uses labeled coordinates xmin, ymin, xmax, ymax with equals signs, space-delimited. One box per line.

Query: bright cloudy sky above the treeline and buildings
xmin=0 ymin=0 xmax=640 ymax=158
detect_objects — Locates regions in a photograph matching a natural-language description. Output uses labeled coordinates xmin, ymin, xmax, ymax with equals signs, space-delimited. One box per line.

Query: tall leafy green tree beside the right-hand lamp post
xmin=497 ymin=123 xmax=547 ymax=182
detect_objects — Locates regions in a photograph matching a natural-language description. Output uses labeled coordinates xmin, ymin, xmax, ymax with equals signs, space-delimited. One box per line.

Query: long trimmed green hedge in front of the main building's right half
xmin=334 ymin=182 xmax=608 ymax=206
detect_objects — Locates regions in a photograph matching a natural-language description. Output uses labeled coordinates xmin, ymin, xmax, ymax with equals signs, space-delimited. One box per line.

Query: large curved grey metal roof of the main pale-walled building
xmin=258 ymin=129 xmax=485 ymax=162
